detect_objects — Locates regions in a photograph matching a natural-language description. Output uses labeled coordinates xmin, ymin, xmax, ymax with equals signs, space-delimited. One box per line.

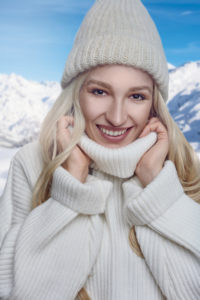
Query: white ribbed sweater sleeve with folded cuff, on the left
xmin=0 ymin=146 xmax=111 ymax=300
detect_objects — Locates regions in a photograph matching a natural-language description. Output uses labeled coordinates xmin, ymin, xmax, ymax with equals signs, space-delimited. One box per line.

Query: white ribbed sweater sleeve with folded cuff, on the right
xmin=124 ymin=161 xmax=200 ymax=300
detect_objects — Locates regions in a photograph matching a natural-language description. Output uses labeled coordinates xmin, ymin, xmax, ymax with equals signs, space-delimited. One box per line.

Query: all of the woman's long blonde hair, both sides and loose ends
xmin=32 ymin=68 xmax=200 ymax=300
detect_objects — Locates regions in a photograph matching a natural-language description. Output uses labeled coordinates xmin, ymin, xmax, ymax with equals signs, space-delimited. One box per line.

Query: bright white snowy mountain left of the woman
xmin=0 ymin=74 xmax=60 ymax=147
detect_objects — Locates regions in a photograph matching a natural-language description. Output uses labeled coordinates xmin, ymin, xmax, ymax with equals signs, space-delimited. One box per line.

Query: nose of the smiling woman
xmin=106 ymin=99 xmax=128 ymax=127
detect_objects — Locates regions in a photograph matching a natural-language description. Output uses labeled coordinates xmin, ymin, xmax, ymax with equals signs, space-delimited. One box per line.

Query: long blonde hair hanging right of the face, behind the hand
xmin=153 ymin=86 xmax=200 ymax=203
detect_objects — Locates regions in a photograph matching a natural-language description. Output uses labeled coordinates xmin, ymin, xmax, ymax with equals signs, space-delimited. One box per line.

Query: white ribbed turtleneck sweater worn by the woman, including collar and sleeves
xmin=0 ymin=133 xmax=200 ymax=300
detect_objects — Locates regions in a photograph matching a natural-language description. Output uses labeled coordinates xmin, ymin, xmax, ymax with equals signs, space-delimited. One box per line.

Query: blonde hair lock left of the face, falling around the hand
xmin=32 ymin=73 xmax=86 ymax=208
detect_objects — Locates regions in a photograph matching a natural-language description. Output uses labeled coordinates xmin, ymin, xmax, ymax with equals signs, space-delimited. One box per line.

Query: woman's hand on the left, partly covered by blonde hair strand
xmin=57 ymin=116 xmax=90 ymax=183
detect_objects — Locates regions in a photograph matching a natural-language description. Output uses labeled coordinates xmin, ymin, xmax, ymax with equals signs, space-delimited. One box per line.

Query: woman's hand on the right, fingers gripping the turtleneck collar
xmin=135 ymin=118 xmax=169 ymax=186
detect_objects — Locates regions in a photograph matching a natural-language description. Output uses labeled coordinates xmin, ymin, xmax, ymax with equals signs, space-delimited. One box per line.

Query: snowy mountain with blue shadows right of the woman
xmin=167 ymin=61 xmax=200 ymax=151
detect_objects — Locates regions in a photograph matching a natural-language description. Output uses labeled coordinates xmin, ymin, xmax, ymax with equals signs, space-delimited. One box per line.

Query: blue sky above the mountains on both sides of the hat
xmin=0 ymin=0 xmax=200 ymax=81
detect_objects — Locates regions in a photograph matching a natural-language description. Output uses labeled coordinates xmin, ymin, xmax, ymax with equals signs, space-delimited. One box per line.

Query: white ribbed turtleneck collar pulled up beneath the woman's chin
xmin=79 ymin=132 xmax=157 ymax=178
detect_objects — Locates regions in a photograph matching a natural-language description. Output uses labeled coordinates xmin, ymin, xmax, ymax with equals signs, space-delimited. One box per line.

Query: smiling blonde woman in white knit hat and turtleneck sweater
xmin=0 ymin=0 xmax=200 ymax=300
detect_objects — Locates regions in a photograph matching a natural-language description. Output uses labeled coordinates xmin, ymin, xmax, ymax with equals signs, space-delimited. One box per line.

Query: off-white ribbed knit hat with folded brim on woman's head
xmin=61 ymin=0 xmax=168 ymax=101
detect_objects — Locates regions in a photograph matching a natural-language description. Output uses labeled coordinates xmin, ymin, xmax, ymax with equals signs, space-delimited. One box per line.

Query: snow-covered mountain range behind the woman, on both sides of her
xmin=0 ymin=61 xmax=200 ymax=151
